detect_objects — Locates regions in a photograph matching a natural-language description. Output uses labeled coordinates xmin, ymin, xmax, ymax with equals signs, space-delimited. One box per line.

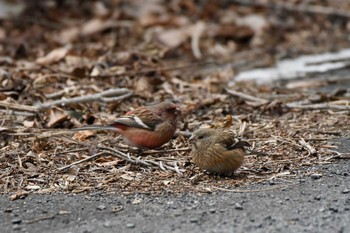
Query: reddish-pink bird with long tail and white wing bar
xmin=73 ymin=101 xmax=180 ymax=149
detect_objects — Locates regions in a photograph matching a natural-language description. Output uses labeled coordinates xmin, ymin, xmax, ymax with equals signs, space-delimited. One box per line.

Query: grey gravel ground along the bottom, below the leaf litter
xmin=0 ymin=139 xmax=350 ymax=233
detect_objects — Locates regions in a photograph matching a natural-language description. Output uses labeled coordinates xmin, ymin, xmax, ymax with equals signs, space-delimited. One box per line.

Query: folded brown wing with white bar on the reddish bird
xmin=111 ymin=108 xmax=162 ymax=131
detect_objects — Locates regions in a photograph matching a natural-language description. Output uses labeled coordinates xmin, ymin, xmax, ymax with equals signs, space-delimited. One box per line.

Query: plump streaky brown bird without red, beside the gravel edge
xmin=189 ymin=128 xmax=250 ymax=174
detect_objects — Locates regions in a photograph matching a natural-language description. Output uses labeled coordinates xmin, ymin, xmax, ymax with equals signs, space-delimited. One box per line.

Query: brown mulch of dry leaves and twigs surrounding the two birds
xmin=0 ymin=0 xmax=350 ymax=199
